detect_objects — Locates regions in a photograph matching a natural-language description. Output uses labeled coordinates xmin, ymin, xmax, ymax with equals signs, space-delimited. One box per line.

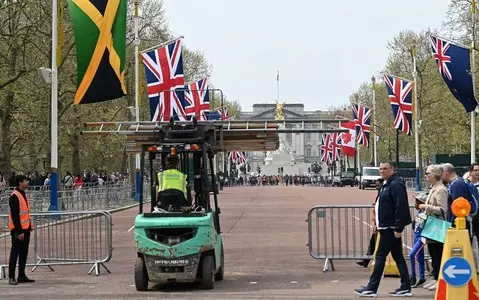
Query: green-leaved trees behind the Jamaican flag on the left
xmin=0 ymin=0 xmax=240 ymax=176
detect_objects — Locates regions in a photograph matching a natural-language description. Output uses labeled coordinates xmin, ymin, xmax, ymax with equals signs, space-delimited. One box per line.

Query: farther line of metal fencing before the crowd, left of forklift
xmin=0 ymin=184 xmax=150 ymax=214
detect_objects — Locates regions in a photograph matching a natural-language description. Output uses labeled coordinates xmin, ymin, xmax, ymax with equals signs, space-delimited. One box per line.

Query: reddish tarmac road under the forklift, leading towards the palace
xmin=0 ymin=187 xmax=434 ymax=300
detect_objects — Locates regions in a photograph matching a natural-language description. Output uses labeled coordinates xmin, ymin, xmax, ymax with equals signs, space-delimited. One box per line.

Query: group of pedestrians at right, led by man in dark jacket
xmin=355 ymin=163 xmax=479 ymax=297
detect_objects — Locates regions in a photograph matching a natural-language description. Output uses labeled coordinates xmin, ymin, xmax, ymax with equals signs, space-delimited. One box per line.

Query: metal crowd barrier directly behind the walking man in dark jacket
xmin=306 ymin=205 xmax=428 ymax=272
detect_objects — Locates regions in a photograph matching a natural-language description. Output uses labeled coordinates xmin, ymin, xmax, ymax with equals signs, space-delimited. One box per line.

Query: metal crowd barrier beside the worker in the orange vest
xmin=0 ymin=211 xmax=113 ymax=279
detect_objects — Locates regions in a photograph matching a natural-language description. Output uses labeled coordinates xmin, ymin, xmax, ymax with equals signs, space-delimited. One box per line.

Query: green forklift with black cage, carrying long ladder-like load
xmin=134 ymin=120 xmax=224 ymax=291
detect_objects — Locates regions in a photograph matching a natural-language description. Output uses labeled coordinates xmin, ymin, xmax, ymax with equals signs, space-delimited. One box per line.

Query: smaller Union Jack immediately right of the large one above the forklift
xmin=182 ymin=78 xmax=210 ymax=121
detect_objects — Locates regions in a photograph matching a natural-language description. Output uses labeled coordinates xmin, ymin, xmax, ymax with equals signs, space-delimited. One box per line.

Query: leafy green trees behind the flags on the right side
xmin=336 ymin=0 xmax=478 ymax=162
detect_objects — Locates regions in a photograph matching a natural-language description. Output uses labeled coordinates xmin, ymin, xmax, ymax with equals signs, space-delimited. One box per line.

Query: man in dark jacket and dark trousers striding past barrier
xmin=355 ymin=163 xmax=412 ymax=297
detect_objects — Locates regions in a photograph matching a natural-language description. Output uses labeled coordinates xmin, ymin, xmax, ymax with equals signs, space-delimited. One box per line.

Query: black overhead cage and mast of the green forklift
xmin=140 ymin=122 xmax=220 ymax=216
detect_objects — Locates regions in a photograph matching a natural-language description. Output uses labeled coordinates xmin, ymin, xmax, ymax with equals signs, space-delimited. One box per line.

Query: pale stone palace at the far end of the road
xmin=236 ymin=103 xmax=334 ymax=174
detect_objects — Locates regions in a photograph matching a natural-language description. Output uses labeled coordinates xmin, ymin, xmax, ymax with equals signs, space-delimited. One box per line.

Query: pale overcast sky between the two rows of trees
xmin=163 ymin=0 xmax=449 ymax=111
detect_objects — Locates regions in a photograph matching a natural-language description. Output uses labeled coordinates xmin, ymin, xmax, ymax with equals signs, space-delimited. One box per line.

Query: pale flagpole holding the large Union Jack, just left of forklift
xmin=134 ymin=0 xmax=141 ymax=201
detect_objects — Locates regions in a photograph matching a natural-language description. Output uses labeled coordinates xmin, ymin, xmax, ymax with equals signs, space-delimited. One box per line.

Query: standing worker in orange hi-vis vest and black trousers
xmin=8 ymin=175 xmax=35 ymax=285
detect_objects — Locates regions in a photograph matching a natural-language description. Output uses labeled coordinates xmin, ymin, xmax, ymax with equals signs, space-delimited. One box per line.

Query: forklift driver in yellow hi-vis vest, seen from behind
xmin=157 ymin=154 xmax=188 ymax=209
